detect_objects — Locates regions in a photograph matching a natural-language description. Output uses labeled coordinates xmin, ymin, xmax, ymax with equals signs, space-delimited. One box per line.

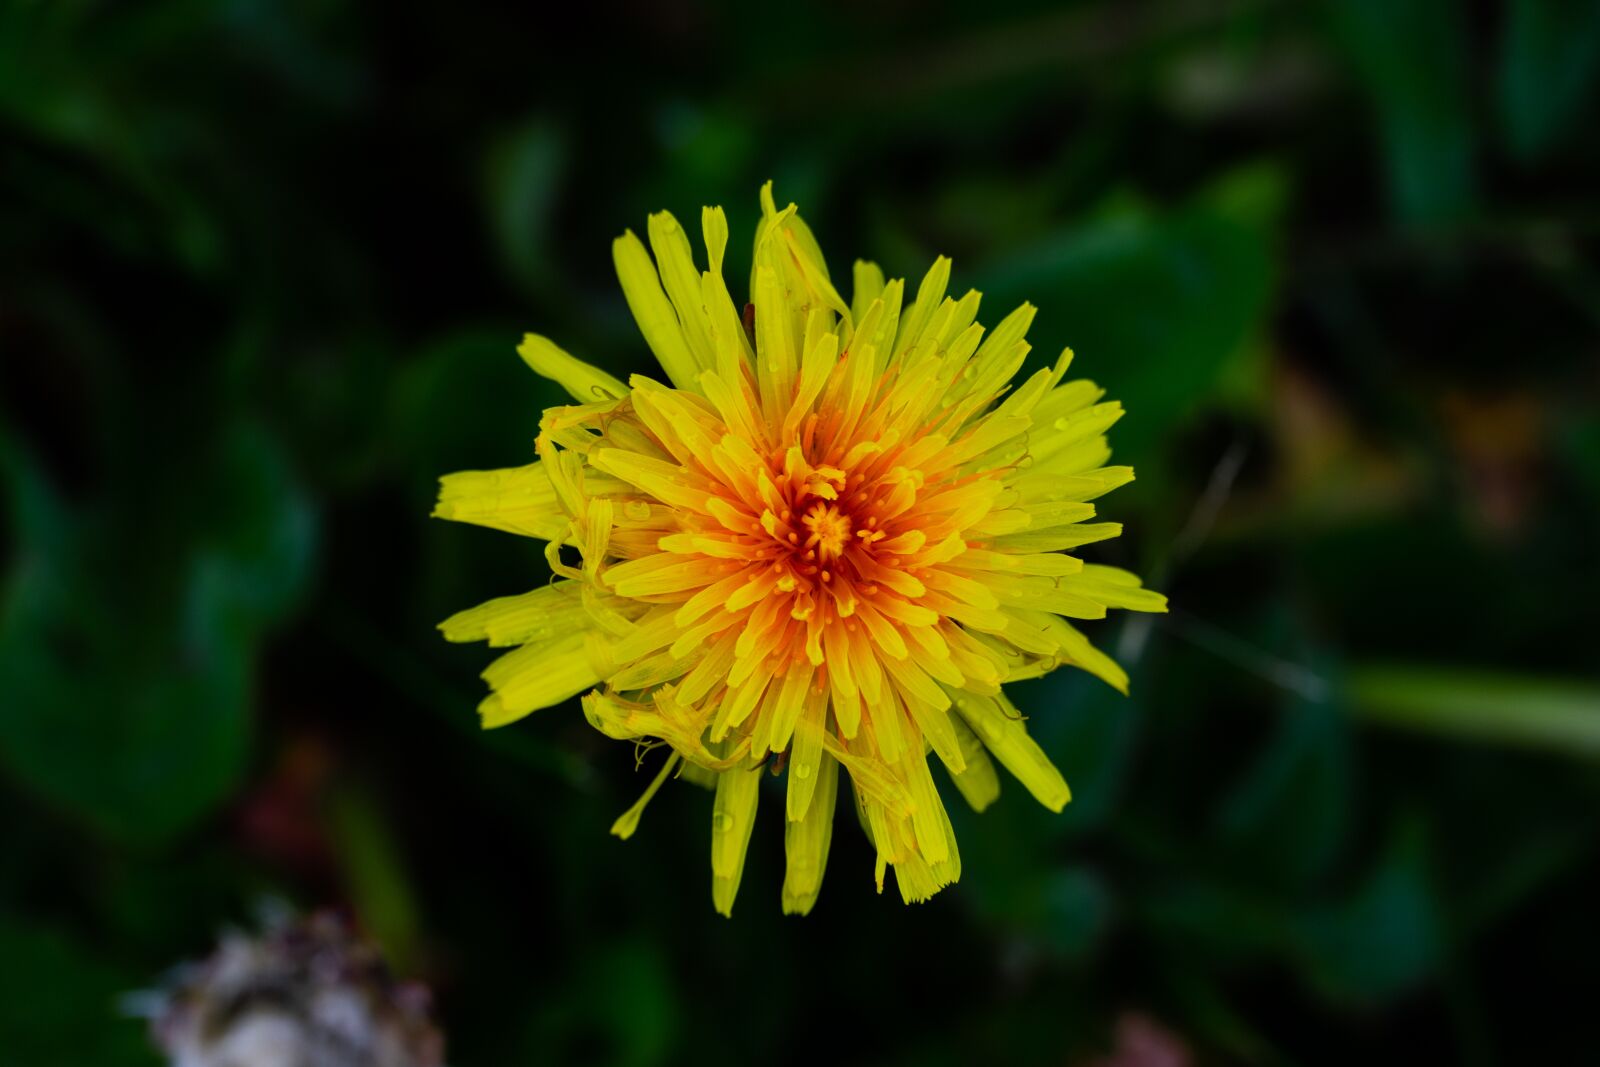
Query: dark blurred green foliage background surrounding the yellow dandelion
xmin=0 ymin=0 xmax=1600 ymax=1067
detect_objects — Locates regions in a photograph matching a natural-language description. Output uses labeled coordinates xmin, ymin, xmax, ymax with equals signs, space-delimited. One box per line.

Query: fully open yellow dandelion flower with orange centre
xmin=434 ymin=184 xmax=1166 ymax=913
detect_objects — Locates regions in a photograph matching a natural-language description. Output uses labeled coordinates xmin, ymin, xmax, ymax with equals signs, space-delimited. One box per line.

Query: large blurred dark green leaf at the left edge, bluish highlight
xmin=0 ymin=427 xmax=312 ymax=841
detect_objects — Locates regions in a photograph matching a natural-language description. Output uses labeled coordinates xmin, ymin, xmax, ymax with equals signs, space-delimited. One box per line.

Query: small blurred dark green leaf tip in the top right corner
xmin=1496 ymin=0 xmax=1600 ymax=163
